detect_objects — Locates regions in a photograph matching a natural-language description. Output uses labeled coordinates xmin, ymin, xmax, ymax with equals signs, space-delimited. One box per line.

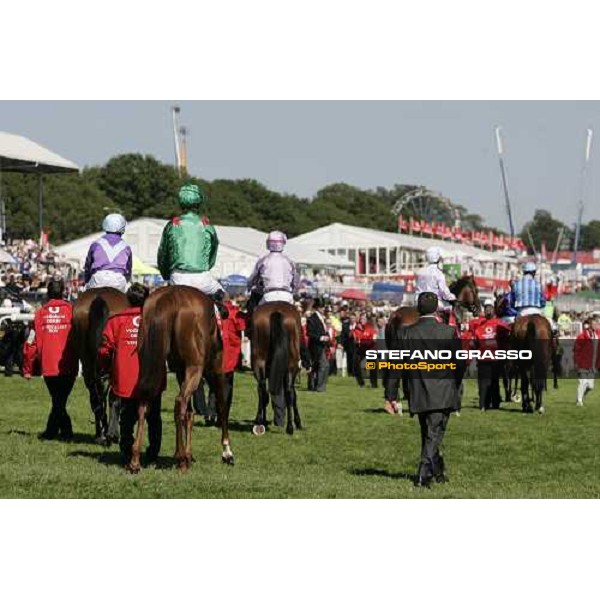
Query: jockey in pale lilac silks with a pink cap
xmin=248 ymin=231 xmax=300 ymax=306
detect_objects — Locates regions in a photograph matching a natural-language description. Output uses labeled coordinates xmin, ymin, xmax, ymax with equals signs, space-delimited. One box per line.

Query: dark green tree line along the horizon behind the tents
xmin=0 ymin=154 xmax=600 ymax=251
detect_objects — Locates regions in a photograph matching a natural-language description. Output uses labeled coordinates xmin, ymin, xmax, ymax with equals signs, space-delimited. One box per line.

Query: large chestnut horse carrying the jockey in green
xmin=137 ymin=285 xmax=234 ymax=472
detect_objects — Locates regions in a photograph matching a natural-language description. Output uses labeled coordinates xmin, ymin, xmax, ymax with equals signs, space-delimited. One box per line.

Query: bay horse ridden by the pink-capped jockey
xmin=250 ymin=302 xmax=302 ymax=435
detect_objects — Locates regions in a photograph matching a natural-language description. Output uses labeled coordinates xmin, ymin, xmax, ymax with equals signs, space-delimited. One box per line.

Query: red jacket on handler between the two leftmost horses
xmin=98 ymin=306 xmax=166 ymax=398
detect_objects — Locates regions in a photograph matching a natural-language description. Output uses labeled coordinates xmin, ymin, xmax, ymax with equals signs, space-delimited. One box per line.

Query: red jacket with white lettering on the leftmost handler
xmin=23 ymin=300 xmax=79 ymax=377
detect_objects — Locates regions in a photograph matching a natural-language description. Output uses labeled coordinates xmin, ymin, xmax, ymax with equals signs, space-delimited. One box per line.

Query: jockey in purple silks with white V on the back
xmin=84 ymin=214 xmax=132 ymax=293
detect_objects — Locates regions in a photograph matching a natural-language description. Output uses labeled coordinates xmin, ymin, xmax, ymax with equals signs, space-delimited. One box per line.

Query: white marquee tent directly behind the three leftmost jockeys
xmin=56 ymin=218 xmax=353 ymax=277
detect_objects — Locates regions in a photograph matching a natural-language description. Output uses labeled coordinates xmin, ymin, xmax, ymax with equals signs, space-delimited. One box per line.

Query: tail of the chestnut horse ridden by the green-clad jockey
xmin=138 ymin=304 xmax=172 ymax=399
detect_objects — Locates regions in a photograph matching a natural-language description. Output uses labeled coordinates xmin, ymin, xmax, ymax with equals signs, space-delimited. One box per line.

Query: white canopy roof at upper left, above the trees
xmin=0 ymin=131 xmax=79 ymax=173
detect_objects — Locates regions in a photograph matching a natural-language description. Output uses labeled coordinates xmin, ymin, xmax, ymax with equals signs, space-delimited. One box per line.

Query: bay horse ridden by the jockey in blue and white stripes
xmin=510 ymin=315 xmax=553 ymax=414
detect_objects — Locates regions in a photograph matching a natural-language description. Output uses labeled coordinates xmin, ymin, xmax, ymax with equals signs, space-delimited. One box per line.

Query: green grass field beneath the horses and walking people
xmin=0 ymin=374 xmax=600 ymax=498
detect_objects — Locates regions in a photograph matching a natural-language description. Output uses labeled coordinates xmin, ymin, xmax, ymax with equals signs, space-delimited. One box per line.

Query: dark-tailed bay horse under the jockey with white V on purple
xmin=73 ymin=287 xmax=129 ymax=444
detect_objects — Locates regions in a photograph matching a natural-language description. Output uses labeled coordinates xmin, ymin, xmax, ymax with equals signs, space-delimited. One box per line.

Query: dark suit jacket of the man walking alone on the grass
xmin=400 ymin=317 xmax=466 ymax=414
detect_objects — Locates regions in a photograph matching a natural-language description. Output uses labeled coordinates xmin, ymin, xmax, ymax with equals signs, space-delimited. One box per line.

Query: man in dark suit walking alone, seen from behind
xmin=401 ymin=292 xmax=466 ymax=487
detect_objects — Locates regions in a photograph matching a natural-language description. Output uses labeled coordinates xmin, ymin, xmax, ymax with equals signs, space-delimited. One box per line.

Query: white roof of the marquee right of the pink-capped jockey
xmin=290 ymin=223 xmax=516 ymax=262
